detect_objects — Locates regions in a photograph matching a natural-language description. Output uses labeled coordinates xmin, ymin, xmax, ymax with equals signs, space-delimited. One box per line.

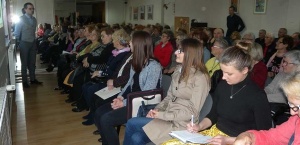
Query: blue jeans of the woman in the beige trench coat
xmin=123 ymin=117 xmax=153 ymax=145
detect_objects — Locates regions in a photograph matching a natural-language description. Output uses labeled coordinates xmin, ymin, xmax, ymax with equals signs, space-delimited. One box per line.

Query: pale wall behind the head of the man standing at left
xmin=11 ymin=0 xmax=54 ymax=24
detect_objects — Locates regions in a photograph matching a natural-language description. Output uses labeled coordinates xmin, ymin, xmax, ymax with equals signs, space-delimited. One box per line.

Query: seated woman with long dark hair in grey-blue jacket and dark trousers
xmin=95 ymin=31 xmax=162 ymax=145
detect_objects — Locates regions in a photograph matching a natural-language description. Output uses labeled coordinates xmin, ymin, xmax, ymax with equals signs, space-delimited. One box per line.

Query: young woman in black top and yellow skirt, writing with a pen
xmin=163 ymin=47 xmax=272 ymax=145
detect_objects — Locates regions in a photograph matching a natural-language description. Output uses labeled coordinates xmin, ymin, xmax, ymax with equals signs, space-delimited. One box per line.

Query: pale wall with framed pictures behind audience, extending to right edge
xmin=126 ymin=0 xmax=300 ymax=36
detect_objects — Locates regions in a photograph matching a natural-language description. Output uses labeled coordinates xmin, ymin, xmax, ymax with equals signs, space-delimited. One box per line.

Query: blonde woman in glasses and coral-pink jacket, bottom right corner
xmin=234 ymin=72 xmax=300 ymax=145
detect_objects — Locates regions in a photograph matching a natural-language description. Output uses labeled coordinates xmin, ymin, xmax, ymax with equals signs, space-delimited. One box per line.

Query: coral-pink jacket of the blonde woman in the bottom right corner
xmin=249 ymin=115 xmax=300 ymax=145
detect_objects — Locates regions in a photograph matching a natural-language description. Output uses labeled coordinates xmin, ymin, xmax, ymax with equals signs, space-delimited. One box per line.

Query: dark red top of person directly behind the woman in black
xmin=251 ymin=61 xmax=268 ymax=89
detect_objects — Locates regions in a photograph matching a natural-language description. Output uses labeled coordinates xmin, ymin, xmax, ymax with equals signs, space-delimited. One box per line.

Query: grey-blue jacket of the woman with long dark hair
xmin=119 ymin=59 xmax=162 ymax=98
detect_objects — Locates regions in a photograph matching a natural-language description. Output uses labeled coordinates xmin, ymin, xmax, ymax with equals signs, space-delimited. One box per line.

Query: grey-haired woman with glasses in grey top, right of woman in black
xmin=265 ymin=50 xmax=300 ymax=125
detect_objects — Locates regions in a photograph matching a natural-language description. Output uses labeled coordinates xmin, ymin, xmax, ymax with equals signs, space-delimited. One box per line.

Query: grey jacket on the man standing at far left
xmin=14 ymin=14 xmax=37 ymax=42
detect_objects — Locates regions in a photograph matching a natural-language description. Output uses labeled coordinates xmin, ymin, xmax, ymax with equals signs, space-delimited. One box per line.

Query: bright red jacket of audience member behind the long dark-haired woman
xmin=154 ymin=42 xmax=173 ymax=68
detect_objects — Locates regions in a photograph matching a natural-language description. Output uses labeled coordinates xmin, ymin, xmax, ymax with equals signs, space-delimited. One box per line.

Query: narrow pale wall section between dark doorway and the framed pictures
xmin=105 ymin=0 xmax=126 ymax=24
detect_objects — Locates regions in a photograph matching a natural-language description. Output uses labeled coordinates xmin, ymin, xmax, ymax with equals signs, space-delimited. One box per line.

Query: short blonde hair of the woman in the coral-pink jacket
xmin=280 ymin=72 xmax=300 ymax=100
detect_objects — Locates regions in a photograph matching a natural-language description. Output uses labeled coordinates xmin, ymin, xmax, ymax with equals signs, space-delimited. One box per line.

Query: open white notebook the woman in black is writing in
xmin=169 ymin=130 xmax=212 ymax=144
